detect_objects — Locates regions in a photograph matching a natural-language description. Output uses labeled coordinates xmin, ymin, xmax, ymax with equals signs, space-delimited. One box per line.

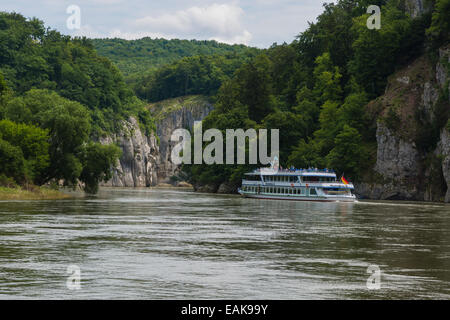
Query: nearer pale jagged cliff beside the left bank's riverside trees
xmin=100 ymin=117 xmax=159 ymax=187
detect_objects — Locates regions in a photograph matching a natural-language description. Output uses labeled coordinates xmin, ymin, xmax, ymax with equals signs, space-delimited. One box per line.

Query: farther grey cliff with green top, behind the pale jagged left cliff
xmin=153 ymin=96 xmax=213 ymax=183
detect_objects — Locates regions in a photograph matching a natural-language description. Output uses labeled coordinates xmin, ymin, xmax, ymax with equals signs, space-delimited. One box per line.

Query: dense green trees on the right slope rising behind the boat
xmin=183 ymin=0 xmax=448 ymax=186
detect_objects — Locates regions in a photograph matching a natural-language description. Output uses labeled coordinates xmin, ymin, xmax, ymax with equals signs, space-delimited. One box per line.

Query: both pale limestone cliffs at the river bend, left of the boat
xmin=99 ymin=96 xmax=213 ymax=187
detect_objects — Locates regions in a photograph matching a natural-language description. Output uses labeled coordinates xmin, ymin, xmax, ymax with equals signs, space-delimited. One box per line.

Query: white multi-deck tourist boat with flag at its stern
xmin=238 ymin=168 xmax=356 ymax=202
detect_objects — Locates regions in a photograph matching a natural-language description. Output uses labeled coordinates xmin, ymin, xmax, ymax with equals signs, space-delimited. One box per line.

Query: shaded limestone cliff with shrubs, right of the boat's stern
xmin=356 ymin=47 xmax=450 ymax=202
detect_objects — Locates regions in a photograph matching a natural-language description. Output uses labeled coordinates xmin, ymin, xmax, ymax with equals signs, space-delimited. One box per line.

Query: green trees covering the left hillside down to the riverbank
xmin=0 ymin=12 xmax=132 ymax=192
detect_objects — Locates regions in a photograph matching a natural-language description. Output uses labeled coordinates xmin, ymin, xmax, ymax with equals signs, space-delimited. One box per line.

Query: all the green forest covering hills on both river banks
xmin=0 ymin=0 xmax=450 ymax=192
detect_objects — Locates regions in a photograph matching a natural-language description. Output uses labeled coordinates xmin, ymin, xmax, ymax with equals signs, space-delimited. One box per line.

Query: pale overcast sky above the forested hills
xmin=0 ymin=0 xmax=332 ymax=48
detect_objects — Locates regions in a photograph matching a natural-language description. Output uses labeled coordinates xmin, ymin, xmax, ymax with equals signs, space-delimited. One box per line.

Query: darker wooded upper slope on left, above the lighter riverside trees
xmin=0 ymin=12 xmax=152 ymax=134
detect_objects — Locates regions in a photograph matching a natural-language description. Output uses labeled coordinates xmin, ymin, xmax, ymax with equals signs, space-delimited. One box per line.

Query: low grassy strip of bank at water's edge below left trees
xmin=0 ymin=187 xmax=70 ymax=200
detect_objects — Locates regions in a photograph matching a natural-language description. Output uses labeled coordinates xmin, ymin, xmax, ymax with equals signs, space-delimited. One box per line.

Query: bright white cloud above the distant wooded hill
xmin=133 ymin=4 xmax=252 ymax=44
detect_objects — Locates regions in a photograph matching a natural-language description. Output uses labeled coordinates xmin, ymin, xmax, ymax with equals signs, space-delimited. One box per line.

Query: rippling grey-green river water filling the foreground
xmin=0 ymin=188 xmax=450 ymax=299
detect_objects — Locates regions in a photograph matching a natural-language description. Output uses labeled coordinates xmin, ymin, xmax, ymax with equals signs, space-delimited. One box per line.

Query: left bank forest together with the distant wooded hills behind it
xmin=0 ymin=12 xmax=260 ymax=193
